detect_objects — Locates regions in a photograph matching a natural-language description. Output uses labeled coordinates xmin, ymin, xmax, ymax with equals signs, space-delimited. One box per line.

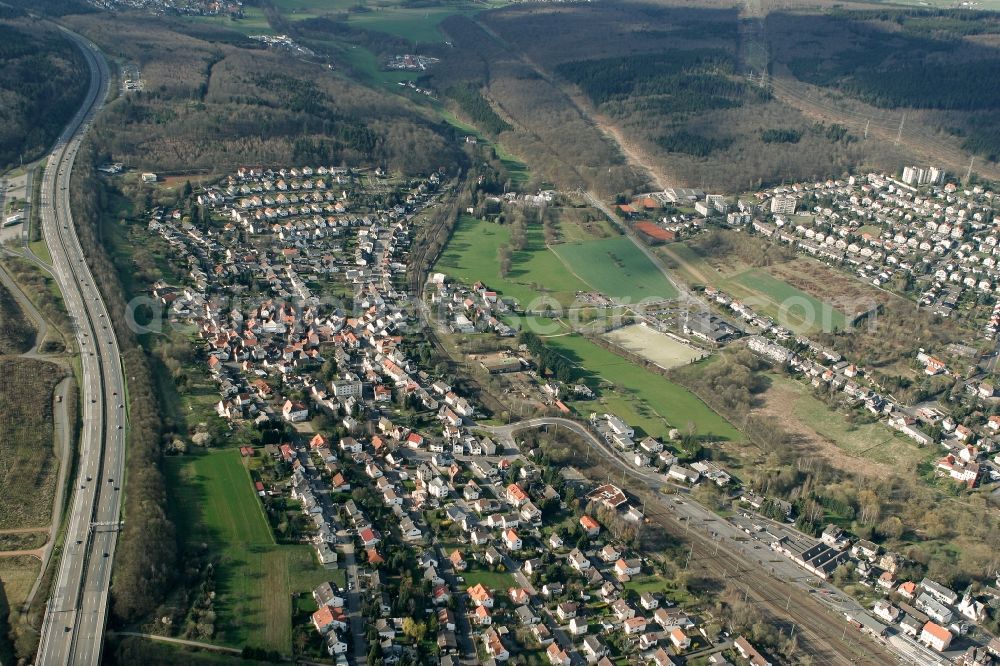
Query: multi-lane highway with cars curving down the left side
xmin=36 ymin=24 xmax=127 ymax=666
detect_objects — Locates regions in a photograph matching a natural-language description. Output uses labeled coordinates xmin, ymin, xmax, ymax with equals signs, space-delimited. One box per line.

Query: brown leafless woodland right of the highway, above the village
xmin=64 ymin=15 xmax=463 ymax=173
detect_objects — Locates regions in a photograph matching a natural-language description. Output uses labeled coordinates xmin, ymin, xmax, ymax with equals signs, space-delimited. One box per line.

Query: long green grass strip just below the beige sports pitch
xmin=545 ymin=335 xmax=742 ymax=440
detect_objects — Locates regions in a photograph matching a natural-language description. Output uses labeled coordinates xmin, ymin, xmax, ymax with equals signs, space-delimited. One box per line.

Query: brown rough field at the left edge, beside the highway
xmin=0 ymin=357 xmax=65 ymax=529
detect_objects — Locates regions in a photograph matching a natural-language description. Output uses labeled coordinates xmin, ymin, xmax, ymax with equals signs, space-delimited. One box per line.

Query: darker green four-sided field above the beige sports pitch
xmin=552 ymin=236 xmax=677 ymax=303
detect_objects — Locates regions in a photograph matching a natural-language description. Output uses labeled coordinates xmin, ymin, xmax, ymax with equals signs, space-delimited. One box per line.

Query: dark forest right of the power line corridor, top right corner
xmin=765 ymin=8 xmax=1000 ymax=162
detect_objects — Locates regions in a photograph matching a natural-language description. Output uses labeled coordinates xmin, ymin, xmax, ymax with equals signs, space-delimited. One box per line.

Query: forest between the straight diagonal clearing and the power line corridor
xmin=476 ymin=2 xmax=908 ymax=192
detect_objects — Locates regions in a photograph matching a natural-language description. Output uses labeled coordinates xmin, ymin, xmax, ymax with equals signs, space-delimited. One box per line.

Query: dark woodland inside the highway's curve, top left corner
xmin=0 ymin=20 xmax=89 ymax=169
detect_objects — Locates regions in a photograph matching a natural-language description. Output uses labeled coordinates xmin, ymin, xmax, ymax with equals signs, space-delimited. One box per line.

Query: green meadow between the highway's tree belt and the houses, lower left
xmin=166 ymin=449 xmax=336 ymax=654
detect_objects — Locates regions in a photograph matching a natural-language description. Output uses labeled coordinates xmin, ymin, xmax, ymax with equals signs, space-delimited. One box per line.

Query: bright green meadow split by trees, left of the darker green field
xmin=434 ymin=215 xmax=588 ymax=306
